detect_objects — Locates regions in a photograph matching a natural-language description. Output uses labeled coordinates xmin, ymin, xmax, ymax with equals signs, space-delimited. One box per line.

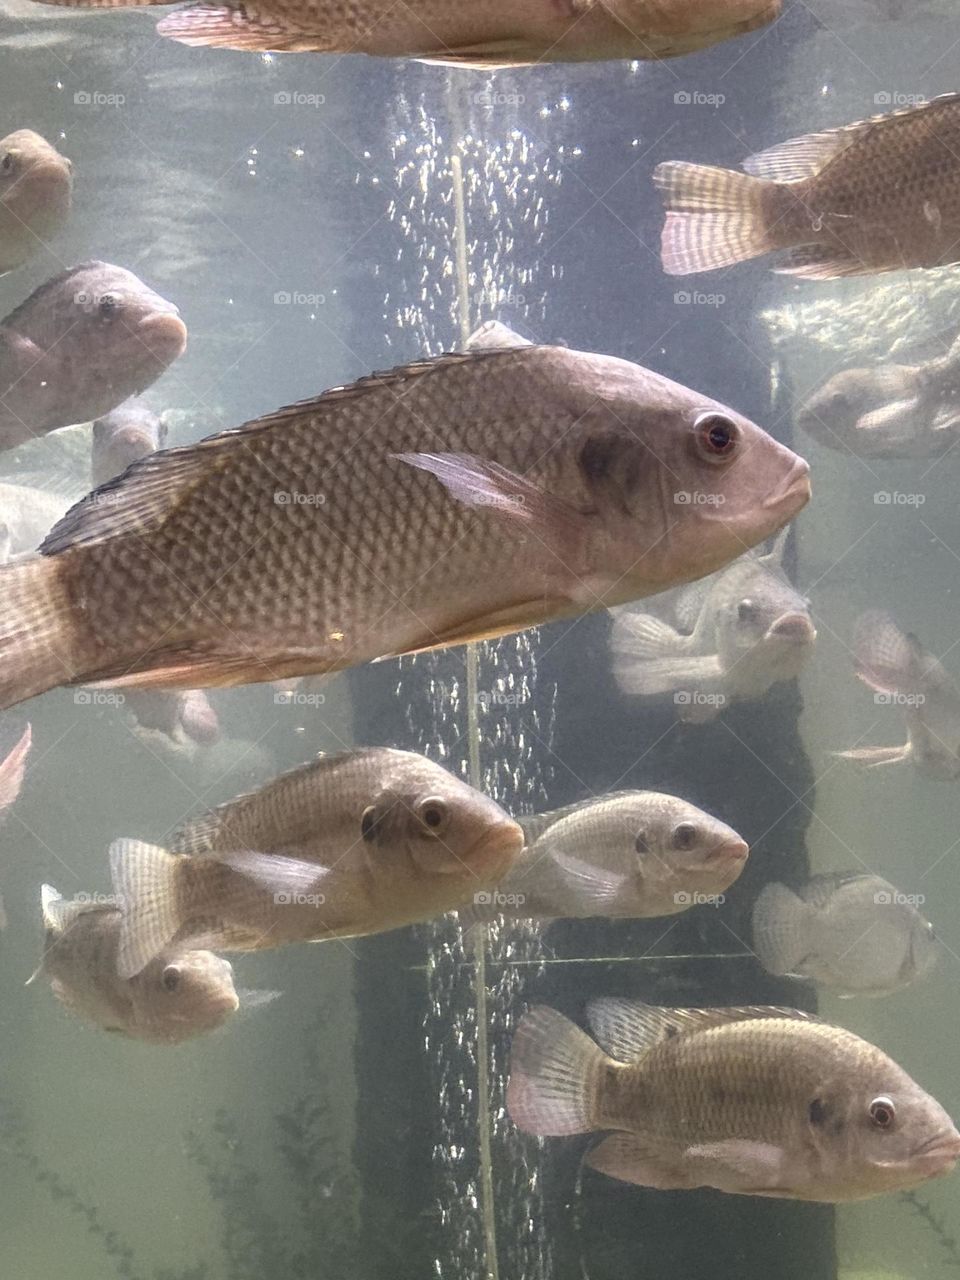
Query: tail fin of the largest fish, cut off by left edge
xmin=0 ymin=556 xmax=74 ymax=709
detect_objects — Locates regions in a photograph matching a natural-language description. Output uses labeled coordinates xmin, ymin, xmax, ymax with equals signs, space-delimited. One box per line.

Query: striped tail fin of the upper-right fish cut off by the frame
xmin=653 ymin=160 xmax=785 ymax=275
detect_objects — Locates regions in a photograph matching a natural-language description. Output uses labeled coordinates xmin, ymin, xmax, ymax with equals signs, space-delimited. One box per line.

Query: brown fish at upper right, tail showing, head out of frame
xmin=654 ymin=93 xmax=960 ymax=280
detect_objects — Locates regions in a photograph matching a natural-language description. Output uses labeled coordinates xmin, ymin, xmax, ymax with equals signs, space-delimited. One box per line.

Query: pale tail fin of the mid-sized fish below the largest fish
xmin=110 ymin=840 xmax=186 ymax=978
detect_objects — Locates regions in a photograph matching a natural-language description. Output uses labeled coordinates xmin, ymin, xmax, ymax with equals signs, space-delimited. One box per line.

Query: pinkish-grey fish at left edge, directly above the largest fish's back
xmin=0 ymin=261 xmax=187 ymax=449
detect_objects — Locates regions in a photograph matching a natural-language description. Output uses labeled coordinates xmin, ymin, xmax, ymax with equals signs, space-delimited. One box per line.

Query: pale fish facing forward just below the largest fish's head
xmin=611 ymin=531 xmax=817 ymax=723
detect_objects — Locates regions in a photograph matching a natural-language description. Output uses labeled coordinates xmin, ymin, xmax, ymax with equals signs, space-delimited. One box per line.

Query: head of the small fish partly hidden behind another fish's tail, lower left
xmin=129 ymin=951 xmax=239 ymax=1044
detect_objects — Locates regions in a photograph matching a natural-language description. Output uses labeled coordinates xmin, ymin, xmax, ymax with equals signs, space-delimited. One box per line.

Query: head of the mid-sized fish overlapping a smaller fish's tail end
xmin=361 ymin=769 xmax=524 ymax=879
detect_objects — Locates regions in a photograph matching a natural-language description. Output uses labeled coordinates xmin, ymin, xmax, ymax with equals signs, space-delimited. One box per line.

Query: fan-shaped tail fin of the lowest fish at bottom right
xmin=507 ymin=1005 xmax=608 ymax=1137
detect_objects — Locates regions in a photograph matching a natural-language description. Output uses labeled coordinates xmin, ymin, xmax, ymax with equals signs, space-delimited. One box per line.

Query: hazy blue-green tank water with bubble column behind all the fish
xmin=0 ymin=0 xmax=960 ymax=1280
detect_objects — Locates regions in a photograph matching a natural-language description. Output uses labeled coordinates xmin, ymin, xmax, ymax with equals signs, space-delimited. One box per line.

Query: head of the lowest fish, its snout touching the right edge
xmin=808 ymin=1046 xmax=960 ymax=1199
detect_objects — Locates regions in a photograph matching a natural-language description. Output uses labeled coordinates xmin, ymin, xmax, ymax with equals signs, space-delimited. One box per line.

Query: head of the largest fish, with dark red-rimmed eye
xmin=577 ymin=357 xmax=810 ymax=595
